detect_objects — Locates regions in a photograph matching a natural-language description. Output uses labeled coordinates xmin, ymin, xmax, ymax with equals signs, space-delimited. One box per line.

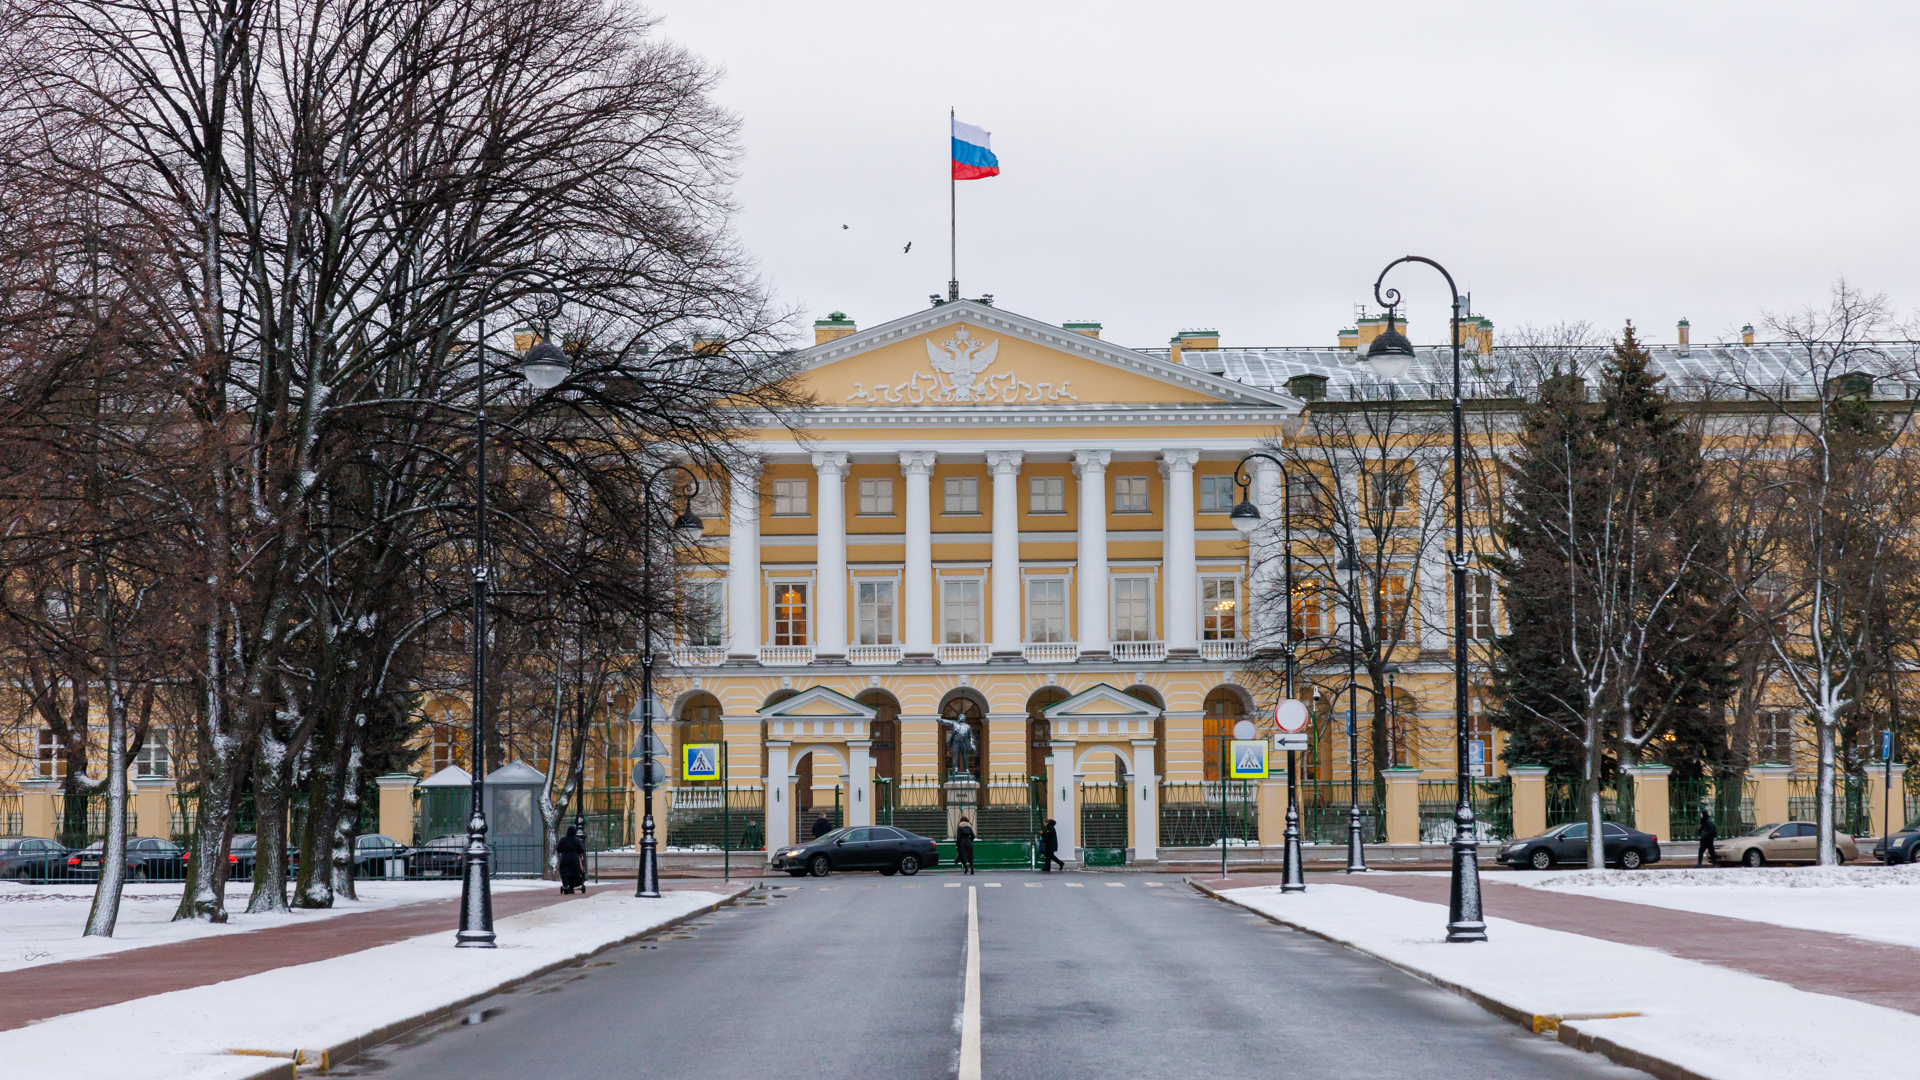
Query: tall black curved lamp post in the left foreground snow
xmin=453 ymin=267 xmax=572 ymax=949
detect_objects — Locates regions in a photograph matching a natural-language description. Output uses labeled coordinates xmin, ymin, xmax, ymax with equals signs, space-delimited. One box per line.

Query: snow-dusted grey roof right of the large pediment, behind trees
xmin=1139 ymin=342 xmax=1920 ymax=402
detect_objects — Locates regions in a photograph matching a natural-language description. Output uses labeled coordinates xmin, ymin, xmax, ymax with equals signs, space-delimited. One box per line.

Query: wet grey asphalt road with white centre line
xmin=334 ymin=872 xmax=1644 ymax=1080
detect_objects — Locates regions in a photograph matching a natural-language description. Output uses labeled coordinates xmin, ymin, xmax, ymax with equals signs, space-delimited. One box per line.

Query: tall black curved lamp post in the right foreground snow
xmin=1367 ymin=256 xmax=1486 ymax=942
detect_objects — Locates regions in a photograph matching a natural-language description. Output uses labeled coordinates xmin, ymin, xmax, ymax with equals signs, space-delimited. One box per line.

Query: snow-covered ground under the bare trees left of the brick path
xmin=0 ymin=880 xmax=553 ymax=970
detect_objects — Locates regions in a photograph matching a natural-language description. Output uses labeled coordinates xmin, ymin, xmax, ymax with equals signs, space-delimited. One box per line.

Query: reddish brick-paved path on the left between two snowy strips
xmin=0 ymin=880 xmax=712 ymax=1032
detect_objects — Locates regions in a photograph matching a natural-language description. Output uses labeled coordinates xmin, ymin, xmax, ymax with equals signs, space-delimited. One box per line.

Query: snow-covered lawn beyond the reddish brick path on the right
xmin=1500 ymin=865 xmax=1920 ymax=945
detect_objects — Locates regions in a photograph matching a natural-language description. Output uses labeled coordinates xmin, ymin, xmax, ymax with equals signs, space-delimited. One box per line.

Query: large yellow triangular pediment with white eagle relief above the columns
xmin=801 ymin=300 xmax=1300 ymax=407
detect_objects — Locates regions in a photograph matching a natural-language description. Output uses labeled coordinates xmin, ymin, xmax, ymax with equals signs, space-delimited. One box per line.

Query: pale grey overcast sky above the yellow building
xmin=653 ymin=0 xmax=1920 ymax=346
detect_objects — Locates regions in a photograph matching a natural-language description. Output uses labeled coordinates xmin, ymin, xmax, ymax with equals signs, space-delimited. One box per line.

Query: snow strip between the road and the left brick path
xmin=0 ymin=890 xmax=720 ymax=1080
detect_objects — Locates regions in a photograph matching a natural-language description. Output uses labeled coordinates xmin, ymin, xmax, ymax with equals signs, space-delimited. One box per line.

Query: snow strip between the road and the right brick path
xmin=1227 ymin=884 xmax=1920 ymax=1080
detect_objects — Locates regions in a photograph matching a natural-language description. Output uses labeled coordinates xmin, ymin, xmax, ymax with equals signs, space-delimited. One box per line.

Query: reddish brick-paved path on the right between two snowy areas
xmin=1196 ymin=871 xmax=1920 ymax=1015
